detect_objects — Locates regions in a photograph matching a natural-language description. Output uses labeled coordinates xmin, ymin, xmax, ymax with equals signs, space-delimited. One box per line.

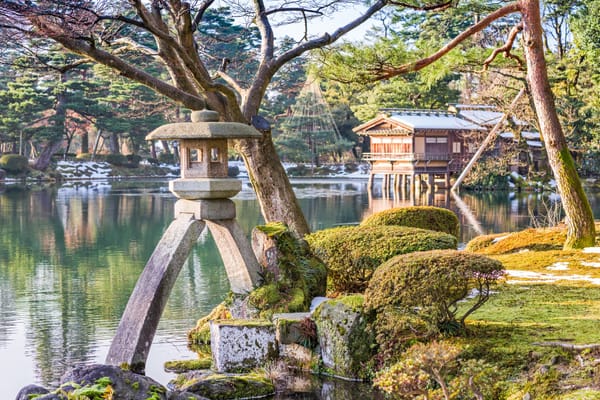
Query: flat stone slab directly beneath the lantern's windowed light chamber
xmin=169 ymin=178 xmax=242 ymax=200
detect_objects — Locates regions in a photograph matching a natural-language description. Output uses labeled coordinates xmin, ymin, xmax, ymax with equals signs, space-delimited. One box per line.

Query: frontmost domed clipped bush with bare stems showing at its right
xmin=365 ymin=250 xmax=503 ymax=333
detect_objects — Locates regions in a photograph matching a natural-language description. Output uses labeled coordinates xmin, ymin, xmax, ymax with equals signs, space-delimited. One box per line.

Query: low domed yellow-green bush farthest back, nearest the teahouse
xmin=361 ymin=206 xmax=460 ymax=237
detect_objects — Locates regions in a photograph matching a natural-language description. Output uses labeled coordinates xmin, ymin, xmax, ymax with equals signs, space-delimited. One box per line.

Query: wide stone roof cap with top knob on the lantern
xmin=146 ymin=110 xmax=262 ymax=140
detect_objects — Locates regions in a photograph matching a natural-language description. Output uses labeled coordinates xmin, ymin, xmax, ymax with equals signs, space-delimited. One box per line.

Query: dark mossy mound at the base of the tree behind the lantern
xmin=248 ymin=223 xmax=327 ymax=318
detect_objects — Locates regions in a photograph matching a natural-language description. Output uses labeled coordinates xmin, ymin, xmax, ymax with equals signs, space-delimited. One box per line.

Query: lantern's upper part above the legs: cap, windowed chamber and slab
xmin=146 ymin=110 xmax=261 ymax=200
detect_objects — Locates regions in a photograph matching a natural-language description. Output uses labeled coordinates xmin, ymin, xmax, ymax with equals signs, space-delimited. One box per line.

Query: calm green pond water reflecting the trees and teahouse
xmin=0 ymin=180 xmax=600 ymax=399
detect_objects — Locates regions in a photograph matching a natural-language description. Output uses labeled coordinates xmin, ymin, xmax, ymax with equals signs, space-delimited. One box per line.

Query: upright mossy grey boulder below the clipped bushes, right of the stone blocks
xmin=313 ymin=295 xmax=375 ymax=379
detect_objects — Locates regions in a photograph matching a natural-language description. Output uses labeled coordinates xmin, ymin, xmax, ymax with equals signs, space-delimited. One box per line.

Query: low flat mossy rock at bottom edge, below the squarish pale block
xmin=171 ymin=372 xmax=275 ymax=400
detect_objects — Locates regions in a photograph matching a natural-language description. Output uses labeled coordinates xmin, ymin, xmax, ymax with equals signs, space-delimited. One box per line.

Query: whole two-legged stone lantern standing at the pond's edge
xmin=106 ymin=110 xmax=261 ymax=373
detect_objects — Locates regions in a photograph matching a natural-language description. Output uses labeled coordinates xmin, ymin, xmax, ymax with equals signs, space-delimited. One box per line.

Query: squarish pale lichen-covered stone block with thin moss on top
xmin=210 ymin=320 xmax=277 ymax=372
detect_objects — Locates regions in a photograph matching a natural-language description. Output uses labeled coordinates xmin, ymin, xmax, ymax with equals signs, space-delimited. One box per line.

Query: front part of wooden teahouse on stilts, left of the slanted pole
xmin=354 ymin=109 xmax=487 ymax=190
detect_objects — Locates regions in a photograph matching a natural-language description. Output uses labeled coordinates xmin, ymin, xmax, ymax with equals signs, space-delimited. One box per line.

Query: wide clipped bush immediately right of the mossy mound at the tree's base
xmin=305 ymin=226 xmax=457 ymax=293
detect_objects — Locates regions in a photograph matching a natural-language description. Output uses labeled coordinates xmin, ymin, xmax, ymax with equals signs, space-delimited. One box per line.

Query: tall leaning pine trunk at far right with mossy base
xmin=519 ymin=0 xmax=596 ymax=249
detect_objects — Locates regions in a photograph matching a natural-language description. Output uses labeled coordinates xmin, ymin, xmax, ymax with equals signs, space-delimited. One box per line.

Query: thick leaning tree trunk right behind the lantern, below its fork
xmin=238 ymin=123 xmax=310 ymax=237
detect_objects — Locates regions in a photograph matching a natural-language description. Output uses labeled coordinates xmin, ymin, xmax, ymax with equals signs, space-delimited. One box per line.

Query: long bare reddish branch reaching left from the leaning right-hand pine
xmin=374 ymin=2 xmax=520 ymax=81
